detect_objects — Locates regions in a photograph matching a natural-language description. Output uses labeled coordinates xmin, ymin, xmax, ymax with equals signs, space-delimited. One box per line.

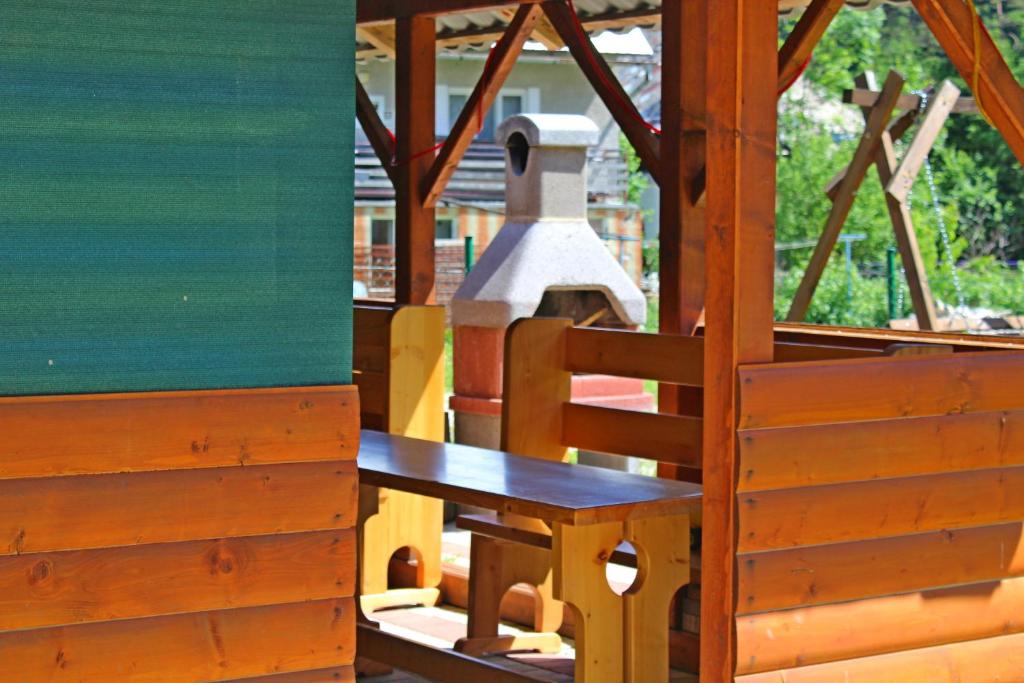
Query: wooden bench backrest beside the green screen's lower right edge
xmin=352 ymin=303 xmax=444 ymax=441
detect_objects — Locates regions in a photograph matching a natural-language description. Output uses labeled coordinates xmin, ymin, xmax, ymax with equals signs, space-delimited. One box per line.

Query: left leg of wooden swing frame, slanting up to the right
xmin=785 ymin=72 xmax=903 ymax=322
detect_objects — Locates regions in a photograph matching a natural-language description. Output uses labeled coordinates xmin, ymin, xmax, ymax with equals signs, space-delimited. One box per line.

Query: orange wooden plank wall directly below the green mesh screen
xmin=0 ymin=387 xmax=358 ymax=683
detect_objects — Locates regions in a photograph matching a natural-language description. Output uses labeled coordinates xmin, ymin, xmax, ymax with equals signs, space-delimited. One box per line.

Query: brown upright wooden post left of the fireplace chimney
xmin=394 ymin=15 xmax=436 ymax=304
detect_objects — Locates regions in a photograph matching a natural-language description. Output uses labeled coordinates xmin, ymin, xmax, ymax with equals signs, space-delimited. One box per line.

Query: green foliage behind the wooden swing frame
xmin=775 ymin=2 xmax=1024 ymax=326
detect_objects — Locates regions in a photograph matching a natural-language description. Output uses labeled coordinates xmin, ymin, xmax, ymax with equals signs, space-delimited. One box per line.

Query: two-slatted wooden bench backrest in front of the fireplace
xmin=502 ymin=317 xmax=703 ymax=467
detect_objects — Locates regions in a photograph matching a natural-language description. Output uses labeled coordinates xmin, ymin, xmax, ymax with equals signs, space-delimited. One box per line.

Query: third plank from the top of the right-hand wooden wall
xmin=737 ymin=467 xmax=1024 ymax=552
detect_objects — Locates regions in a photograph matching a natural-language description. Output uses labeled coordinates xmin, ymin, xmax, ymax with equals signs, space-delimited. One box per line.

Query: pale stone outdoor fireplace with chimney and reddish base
xmin=451 ymin=114 xmax=652 ymax=447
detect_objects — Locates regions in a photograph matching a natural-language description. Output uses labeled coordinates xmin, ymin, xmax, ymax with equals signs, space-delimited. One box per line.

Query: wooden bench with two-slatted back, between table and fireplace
xmin=458 ymin=318 xmax=703 ymax=654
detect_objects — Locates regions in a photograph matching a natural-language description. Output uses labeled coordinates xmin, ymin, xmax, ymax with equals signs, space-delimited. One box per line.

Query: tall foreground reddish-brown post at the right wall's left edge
xmin=700 ymin=0 xmax=778 ymax=683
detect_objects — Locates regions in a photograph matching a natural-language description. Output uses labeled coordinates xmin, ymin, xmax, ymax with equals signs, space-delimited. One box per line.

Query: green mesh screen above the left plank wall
xmin=0 ymin=0 xmax=355 ymax=394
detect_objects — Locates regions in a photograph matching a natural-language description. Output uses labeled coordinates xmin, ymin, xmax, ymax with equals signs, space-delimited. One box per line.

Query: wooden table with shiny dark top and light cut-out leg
xmin=358 ymin=431 xmax=700 ymax=683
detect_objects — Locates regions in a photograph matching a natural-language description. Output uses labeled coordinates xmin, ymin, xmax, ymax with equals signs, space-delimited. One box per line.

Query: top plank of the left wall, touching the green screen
xmin=0 ymin=386 xmax=358 ymax=479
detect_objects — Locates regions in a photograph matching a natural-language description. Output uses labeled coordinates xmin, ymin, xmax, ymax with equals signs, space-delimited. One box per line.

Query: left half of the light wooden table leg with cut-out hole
xmin=552 ymin=522 xmax=618 ymax=683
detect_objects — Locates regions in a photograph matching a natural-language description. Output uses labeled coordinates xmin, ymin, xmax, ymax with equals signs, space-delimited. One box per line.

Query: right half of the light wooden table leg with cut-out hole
xmin=624 ymin=514 xmax=690 ymax=683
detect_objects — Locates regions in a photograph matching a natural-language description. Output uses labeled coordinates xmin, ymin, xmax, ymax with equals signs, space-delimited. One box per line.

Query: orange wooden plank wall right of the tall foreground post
xmin=735 ymin=351 xmax=1024 ymax=683
